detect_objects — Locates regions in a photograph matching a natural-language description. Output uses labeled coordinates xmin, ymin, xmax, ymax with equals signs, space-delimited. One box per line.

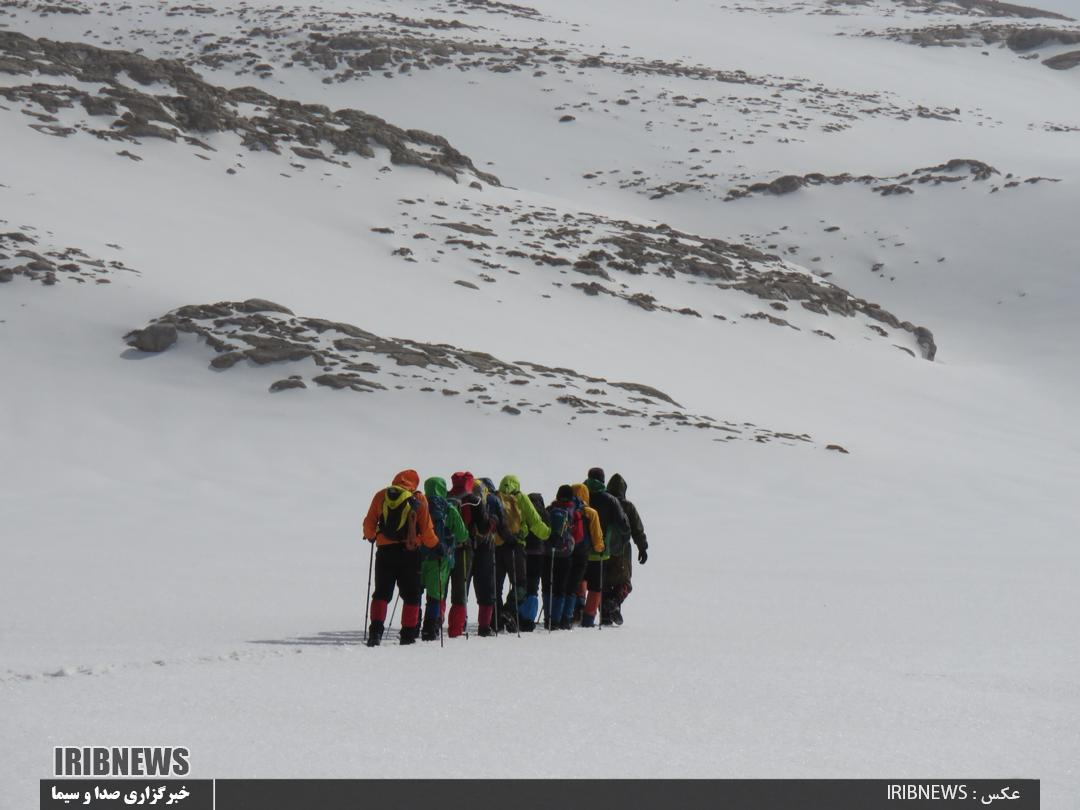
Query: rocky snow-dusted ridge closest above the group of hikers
xmin=127 ymin=298 xmax=810 ymax=443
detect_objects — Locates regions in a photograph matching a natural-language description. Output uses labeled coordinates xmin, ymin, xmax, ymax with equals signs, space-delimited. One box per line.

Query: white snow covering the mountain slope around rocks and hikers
xmin=0 ymin=0 xmax=1080 ymax=808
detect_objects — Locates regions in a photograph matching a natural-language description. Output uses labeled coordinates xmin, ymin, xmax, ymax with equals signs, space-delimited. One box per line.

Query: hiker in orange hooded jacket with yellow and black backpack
xmin=364 ymin=470 xmax=438 ymax=647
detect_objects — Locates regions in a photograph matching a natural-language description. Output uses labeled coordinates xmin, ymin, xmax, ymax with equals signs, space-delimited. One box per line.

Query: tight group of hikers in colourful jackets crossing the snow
xmin=364 ymin=467 xmax=649 ymax=647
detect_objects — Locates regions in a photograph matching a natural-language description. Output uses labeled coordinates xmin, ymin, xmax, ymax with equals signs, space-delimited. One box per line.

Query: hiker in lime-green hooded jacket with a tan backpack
xmin=495 ymin=475 xmax=551 ymax=633
